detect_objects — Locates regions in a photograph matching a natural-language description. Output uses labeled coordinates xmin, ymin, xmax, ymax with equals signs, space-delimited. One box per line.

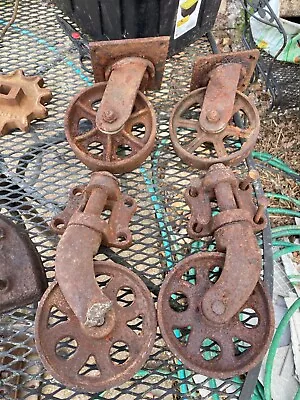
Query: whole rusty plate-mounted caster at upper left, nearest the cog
xmin=65 ymin=37 xmax=169 ymax=173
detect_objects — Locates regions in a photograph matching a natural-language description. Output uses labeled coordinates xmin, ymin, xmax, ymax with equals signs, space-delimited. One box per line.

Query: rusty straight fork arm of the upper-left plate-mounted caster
xmin=96 ymin=57 xmax=155 ymax=135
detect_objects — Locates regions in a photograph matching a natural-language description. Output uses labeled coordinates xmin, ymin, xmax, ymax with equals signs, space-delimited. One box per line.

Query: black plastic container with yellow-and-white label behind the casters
xmin=54 ymin=0 xmax=221 ymax=55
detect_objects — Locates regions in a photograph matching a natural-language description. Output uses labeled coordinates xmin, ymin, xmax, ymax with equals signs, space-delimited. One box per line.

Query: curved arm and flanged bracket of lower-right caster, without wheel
xmin=185 ymin=164 xmax=266 ymax=323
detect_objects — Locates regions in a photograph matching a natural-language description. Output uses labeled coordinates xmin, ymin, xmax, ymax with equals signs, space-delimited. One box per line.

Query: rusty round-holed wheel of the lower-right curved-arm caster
xmin=158 ymin=253 xmax=274 ymax=379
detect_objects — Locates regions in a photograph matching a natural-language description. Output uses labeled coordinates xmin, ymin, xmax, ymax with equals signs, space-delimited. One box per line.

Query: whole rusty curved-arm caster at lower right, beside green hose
xmin=158 ymin=164 xmax=274 ymax=378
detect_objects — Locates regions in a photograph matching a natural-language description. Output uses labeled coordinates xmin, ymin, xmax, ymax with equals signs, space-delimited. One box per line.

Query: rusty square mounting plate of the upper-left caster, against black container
xmin=90 ymin=36 xmax=170 ymax=90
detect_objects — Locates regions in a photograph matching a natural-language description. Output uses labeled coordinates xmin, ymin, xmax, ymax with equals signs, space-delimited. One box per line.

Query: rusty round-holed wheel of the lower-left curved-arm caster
xmin=35 ymin=261 xmax=157 ymax=392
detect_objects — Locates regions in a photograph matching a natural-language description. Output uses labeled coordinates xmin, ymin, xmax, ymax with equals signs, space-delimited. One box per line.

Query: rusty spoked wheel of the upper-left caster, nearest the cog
xmin=65 ymin=82 xmax=156 ymax=174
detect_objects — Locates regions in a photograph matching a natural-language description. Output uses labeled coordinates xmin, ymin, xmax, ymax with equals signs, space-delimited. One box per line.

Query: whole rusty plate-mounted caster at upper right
xmin=170 ymin=52 xmax=260 ymax=169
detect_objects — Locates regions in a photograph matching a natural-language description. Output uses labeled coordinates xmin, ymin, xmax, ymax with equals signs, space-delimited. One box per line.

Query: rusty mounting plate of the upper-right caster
xmin=191 ymin=49 xmax=259 ymax=92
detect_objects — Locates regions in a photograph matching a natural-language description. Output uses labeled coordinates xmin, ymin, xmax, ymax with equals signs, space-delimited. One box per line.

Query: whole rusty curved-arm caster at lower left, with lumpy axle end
xmin=36 ymin=172 xmax=156 ymax=392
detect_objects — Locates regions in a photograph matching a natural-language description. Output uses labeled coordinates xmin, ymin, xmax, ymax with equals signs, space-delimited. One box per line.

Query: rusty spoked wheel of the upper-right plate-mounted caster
xmin=170 ymin=88 xmax=260 ymax=169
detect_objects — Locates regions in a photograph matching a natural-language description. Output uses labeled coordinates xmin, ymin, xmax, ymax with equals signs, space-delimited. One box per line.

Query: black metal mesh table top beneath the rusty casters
xmin=0 ymin=0 xmax=270 ymax=400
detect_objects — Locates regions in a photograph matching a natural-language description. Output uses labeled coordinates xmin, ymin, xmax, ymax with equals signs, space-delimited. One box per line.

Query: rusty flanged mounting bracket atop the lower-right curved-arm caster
xmin=185 ymin=164 xmax=267 ymax=240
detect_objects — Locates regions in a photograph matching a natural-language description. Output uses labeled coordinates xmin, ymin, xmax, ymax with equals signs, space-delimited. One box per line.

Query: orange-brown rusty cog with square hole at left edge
xmin=0 ymin=70 xmax=52 ymax=136
